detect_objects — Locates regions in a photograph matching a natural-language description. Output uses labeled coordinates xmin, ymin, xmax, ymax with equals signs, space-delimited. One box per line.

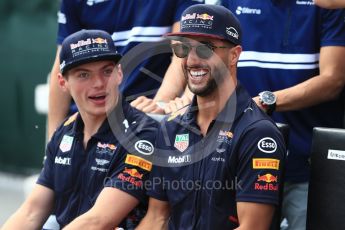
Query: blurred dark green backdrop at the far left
xmin=0 ymin=0 xmax=58 ymax=173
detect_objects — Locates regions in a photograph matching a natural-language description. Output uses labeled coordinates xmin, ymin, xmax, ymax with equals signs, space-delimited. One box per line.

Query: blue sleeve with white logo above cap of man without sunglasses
xmin=57 ymin=0 xmax=82 ymax=44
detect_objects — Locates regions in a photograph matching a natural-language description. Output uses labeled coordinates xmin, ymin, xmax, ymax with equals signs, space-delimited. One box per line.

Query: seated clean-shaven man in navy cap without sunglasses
xmin=3 ymin=30 xmax=157 ymax=229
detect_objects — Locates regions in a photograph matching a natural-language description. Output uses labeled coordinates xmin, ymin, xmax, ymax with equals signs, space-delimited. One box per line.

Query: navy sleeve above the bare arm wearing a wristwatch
xmin=320 ymin=9 xmax=345 ymax=46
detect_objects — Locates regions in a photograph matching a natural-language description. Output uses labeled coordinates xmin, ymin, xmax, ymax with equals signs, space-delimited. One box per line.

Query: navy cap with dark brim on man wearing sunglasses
xmin=165 ymin=4 xmax=242 ymax=45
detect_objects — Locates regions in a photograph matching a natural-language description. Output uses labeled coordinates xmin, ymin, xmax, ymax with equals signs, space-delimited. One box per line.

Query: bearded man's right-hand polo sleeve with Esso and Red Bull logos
xmin=236 ymin=120 xmax=286 ymax=205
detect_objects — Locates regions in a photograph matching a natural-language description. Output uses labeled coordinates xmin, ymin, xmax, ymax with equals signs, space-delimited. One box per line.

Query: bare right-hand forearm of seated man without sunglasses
xmin=64 ymin=187 xmax=139 ymax=230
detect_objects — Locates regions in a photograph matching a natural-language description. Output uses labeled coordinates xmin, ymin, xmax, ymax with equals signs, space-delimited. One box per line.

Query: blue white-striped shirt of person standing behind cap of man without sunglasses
xmin=58 ymin=0 xmax=203 ymax=100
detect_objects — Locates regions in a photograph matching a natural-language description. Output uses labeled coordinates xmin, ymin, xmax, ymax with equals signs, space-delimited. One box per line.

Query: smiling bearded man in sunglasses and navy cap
xmin=138 ymin=5 xmax=285 ymax=230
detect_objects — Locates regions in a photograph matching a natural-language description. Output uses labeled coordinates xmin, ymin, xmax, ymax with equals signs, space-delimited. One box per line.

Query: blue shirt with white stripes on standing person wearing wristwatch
xmin=221 ymin=0 xmax=345 ymax=182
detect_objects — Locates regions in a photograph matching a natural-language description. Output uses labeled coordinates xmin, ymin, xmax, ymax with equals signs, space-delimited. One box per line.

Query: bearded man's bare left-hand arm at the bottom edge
xmin=136 ymin=198 xmax=170 ymax=230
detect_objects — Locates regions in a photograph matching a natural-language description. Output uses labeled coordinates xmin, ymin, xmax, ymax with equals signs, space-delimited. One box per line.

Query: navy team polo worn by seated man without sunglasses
xmin=37 ymin=100 xmax=157 ymax=229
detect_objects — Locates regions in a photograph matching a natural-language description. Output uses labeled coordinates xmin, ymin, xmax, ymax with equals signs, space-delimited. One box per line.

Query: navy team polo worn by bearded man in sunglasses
xmin=148 ymin=83 xmax=285 ymax=229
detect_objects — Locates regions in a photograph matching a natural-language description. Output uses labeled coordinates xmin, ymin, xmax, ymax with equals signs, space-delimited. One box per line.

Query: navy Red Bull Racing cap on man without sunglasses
xmin=60 ymin=30 xmax=122 ymax=74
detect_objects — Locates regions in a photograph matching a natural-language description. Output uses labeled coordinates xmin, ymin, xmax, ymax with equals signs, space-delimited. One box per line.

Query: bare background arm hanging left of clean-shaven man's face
xmin=48 ymin=45 xmax=71 ymax=140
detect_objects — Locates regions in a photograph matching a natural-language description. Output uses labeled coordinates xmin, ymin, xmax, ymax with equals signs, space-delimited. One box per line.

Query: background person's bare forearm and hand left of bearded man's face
xmin=131 ymin=22 xmax=186 ymax=114
